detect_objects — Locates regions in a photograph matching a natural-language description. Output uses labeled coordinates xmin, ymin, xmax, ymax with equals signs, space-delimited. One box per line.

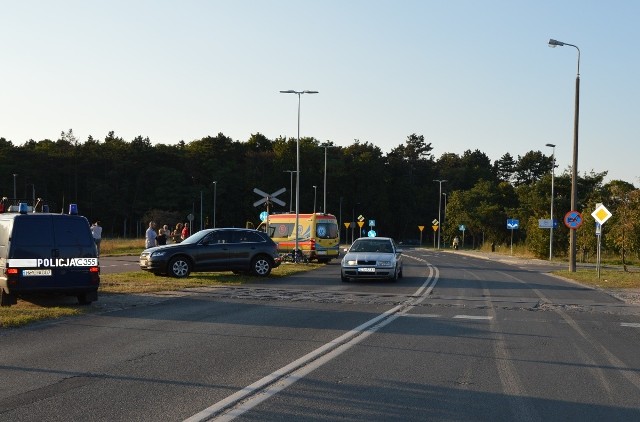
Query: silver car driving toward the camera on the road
xmin=340 ymin=237 xmax=402 ymax=282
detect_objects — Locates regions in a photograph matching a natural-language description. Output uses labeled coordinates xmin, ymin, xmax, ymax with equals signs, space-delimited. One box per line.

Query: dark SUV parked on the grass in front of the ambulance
xmin=140 ymin=228 xmax=280 ymax=278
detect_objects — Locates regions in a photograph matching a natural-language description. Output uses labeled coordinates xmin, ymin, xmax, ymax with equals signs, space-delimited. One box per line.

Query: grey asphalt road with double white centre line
xmin=0 ymin=250 xmax=640 ymax=421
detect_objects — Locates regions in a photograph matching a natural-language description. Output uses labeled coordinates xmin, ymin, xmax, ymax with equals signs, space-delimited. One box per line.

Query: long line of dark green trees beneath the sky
xmin=0 ymin=129 xmax=640 ymax=260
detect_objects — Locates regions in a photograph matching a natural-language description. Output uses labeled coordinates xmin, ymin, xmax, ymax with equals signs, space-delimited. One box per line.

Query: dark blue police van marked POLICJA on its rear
xmin=0 ymin=198 xmax=100 ymax=306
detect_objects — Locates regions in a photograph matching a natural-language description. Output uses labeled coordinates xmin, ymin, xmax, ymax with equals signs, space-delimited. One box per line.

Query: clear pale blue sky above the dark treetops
xmin=0 ymin=0 xmax=640 ymax=186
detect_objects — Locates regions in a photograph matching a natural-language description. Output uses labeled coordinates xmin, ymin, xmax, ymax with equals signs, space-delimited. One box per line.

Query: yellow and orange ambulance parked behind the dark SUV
xmin=258 ymin=213 xmax=340 ymax=263
